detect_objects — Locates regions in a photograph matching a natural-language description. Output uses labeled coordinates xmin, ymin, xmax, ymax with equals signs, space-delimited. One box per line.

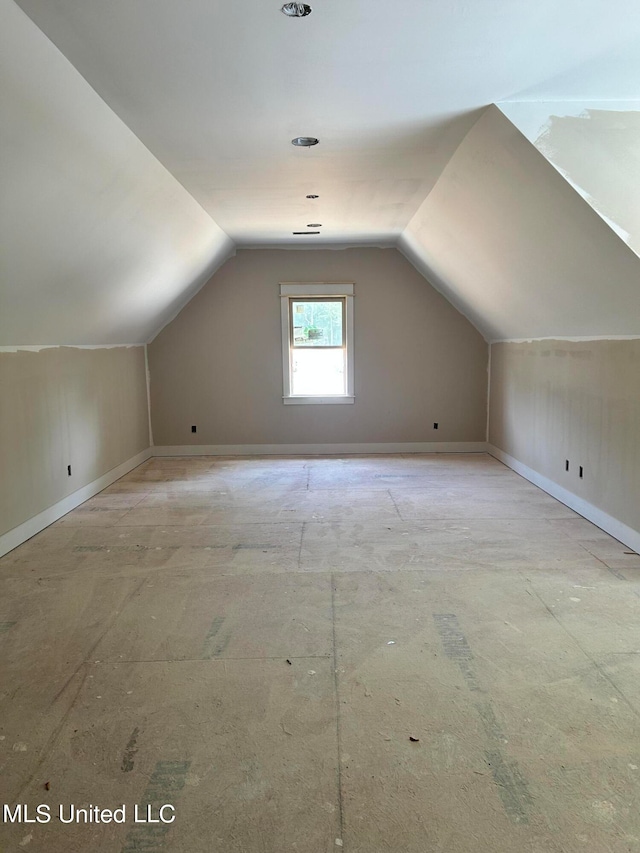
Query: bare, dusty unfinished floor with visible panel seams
xmin=0 ymin=455 xmax=640 ymax=853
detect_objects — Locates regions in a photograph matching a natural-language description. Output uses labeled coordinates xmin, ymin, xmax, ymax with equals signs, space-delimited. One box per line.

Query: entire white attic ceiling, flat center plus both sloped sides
xmin=0 ymin=0 xmax=640 ymax=345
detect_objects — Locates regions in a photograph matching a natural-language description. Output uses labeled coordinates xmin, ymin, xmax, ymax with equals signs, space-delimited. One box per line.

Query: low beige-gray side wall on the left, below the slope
xmin=0 ymin=347 xmax=149 ymax=535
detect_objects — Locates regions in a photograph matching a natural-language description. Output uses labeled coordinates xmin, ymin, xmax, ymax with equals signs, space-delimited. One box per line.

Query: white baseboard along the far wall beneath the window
xmin=152 ymin=441 xmax=487 ymax=456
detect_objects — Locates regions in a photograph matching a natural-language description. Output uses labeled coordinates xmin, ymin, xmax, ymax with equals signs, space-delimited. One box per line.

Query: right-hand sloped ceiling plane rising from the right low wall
xmin=400 ymin=106 xmax=640 ymax=340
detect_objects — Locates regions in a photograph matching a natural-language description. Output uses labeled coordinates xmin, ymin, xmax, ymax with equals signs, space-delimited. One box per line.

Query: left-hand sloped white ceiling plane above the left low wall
xmin=0 ymin=0 xmax=233 ymax=346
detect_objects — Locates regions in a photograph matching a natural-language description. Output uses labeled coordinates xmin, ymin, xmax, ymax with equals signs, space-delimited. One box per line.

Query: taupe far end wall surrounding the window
xmin=148 ymin=249 xmax=488 ymax=445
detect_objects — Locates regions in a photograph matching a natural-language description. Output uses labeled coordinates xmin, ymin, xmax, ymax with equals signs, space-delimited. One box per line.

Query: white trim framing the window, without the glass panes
xmin=280 ymin=281 xmax=355 ymax=406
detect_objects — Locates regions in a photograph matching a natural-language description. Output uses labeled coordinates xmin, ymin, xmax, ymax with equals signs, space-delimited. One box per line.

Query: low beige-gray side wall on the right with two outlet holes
xmin=489 ymin=340 xmax=640 ymax=531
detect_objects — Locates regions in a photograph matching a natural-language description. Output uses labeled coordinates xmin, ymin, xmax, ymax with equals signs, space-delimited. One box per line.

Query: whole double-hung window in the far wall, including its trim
xmin=280 ymin=282 xmax=354 ymax=405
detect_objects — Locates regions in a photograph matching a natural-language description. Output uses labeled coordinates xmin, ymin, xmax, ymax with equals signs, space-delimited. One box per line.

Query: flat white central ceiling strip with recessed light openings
xmin=13 ymin=0 xmax=640 ymax=245
